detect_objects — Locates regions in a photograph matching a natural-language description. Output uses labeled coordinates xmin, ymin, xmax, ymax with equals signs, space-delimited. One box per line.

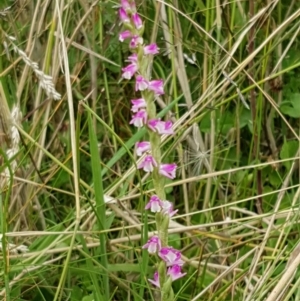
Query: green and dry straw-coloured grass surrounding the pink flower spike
xmin=0 ymin=0 xmax=300 ymax=301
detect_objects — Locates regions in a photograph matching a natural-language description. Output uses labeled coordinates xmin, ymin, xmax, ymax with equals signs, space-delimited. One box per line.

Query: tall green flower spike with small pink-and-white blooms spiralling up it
xmin=119 ymin=0 xmax=186 ymax=301
